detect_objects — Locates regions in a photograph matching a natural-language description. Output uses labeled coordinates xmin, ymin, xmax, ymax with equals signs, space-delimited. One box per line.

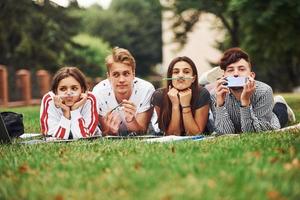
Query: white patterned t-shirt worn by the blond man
xmin=93 ymin=77 xmax=155 ymax=131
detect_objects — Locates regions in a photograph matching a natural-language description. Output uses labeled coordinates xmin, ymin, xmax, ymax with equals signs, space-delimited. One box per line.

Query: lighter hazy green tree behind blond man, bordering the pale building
xmin=83 ymin=0 xmax=162 ymax=76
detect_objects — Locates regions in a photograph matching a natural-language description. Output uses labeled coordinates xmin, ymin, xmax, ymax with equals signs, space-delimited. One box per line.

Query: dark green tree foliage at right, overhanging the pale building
xmin=167 ymin=0 xmax=300 ymax=91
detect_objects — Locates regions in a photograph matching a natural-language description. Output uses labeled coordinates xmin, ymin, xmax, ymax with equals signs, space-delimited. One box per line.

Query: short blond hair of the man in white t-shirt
xmin=105 ymin=47 xmax=135 ymax=72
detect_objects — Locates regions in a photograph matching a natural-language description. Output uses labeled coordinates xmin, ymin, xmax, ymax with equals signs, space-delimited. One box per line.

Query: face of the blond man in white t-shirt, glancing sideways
xmin=107 ymin=63 xmax=135 ymax=96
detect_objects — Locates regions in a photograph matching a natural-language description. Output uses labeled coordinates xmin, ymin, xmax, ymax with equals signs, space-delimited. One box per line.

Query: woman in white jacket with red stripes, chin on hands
xmin=40 ymin=67 xmax=101 ymax=139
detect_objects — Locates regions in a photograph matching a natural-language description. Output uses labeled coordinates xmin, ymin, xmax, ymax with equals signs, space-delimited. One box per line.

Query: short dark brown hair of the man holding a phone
xmin=220 ymin=47 xmax=251 ymax=71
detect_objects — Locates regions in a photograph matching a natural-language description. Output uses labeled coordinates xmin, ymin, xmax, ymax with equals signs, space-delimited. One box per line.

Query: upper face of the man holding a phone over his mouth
xmin=224 ymin=59 xmax=255 ymax=78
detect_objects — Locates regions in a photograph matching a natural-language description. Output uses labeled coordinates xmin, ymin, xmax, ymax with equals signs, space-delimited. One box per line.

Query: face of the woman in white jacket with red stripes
xmin=57 ymin=76 xmax=82 ymax=106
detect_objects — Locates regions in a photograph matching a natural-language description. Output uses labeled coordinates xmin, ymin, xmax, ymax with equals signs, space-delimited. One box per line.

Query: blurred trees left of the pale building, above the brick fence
xmin=0 ymin=0 xmax=162 ymax=77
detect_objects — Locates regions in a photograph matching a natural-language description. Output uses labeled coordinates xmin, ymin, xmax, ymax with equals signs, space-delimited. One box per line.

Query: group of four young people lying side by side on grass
xmin=40 ymin=48 xmax=295 ymax=139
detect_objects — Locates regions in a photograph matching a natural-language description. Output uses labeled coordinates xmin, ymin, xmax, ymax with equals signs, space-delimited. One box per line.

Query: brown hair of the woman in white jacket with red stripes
xmin=51 ymin=67 xmax=88 ymax=94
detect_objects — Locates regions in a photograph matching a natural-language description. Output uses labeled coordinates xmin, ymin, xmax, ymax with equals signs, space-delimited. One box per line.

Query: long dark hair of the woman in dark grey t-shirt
xmin=158 ymin=56 xmax=200 ymax=133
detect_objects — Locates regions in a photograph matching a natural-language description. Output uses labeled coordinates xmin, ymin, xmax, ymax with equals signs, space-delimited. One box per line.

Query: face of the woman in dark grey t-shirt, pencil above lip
xmin=172 ymin=61 xmax=195 ymax=90
